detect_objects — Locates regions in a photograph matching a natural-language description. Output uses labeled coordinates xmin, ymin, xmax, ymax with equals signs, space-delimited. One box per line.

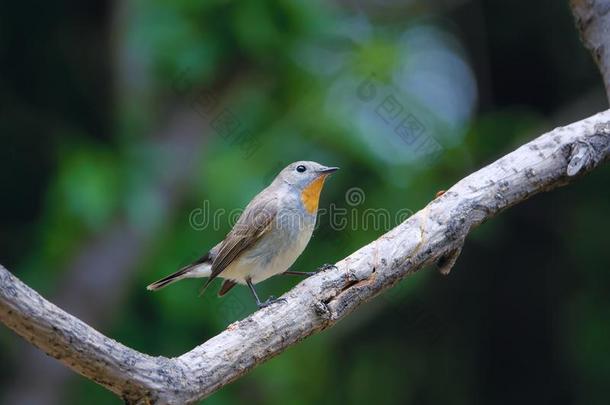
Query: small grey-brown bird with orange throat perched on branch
xmin=147 ymin=161 xmax=338 ymax=308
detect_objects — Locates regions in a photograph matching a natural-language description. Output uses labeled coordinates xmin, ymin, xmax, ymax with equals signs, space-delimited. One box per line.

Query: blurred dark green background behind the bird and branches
xmin=0 ymin=0 xmax=610 ymax=405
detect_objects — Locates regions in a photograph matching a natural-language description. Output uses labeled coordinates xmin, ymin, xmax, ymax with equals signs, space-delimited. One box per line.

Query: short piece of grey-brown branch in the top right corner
xmin=570 ymin=0 xmax=610 ymax=101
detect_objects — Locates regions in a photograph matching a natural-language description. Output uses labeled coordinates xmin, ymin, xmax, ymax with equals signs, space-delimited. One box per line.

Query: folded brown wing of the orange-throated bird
xmin=206 ymin=193 xmax=277 ymax=286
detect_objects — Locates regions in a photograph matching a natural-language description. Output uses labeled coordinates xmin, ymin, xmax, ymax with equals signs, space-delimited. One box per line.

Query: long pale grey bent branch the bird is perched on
xmin=0 ymin=110 xmax=610 ymax=404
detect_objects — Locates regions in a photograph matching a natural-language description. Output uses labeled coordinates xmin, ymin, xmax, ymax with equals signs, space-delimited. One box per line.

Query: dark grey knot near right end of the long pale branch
xmin=566 ymin=122 xmax=610 ymax=177
